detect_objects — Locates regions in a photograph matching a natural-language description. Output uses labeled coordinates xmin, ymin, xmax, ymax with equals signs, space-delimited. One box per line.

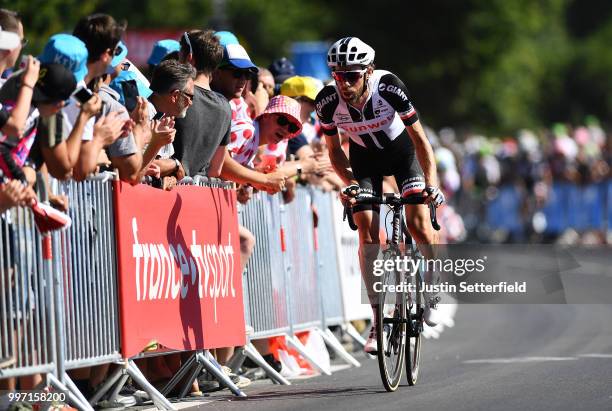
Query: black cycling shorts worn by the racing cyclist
xmin=349 ymin=131 xmax=425 ymax=212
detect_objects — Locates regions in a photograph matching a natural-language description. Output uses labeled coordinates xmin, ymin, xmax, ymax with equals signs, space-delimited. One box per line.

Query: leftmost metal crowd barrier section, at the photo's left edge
xmin=0 ymin=208 xmax=56 ymax=378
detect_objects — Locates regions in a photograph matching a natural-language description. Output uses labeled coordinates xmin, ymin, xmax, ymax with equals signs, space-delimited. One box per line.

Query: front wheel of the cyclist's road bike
xmin=376 ymin=248 xmax=407 ymax=391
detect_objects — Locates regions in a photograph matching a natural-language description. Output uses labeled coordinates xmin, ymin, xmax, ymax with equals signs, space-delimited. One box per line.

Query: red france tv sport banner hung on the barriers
xmin=114 ymin=181 xmax=245 ymax=358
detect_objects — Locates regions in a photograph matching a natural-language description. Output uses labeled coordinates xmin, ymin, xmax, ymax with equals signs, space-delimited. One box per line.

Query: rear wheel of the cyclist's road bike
xmin=406 ymin=254 xmax=425 ymax=385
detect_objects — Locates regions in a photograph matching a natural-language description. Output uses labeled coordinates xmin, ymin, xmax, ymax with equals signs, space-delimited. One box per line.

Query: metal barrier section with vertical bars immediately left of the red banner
xmin=54 ymin=175 xmax=121 ymax=369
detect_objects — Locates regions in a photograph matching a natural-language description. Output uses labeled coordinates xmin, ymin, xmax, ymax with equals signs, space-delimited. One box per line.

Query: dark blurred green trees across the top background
xmin=4 ymin=0 xmax=612 ymax=133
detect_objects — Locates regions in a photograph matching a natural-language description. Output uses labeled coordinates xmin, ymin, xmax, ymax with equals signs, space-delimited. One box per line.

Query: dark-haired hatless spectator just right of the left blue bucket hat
xmin=71 ymin=14 xmax=144 ymax=184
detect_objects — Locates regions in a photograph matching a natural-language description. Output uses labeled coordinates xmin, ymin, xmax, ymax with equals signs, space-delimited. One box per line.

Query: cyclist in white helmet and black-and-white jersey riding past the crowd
xmin=315 ymin=37 xmax=445 ymax=353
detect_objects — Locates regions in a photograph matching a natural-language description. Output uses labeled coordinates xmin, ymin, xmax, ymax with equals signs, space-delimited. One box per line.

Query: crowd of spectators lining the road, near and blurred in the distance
xmin=0 ymin=9 xmax=612 ymax=410
